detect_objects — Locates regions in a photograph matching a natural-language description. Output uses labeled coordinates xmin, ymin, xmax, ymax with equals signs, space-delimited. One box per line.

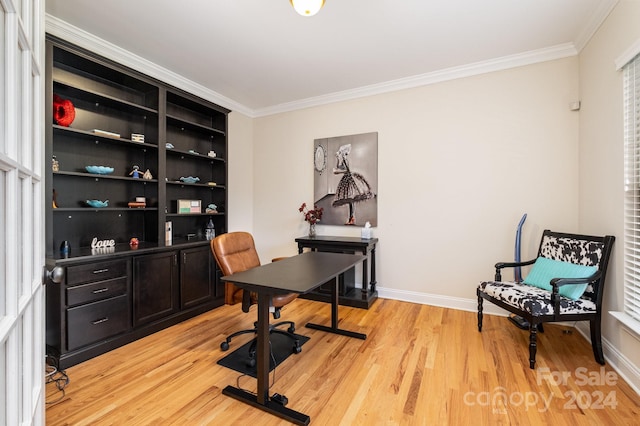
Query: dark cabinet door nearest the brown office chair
xmin=180 ymin=246 xmax=216 ymax=309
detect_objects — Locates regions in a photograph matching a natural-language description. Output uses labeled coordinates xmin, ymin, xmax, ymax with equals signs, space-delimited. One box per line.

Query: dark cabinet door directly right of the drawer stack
xmin=133 ymin=251 xmax=180 ymax=326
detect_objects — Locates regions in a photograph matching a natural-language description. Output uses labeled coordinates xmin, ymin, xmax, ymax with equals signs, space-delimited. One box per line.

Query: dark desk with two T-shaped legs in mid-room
xmin=220 ymin=252 xmax=367 ymax=425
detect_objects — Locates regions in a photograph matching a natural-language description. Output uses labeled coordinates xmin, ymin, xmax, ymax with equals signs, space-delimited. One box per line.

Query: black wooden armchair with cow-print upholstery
xmin=476 ymin=230 xmax=615 ymax=369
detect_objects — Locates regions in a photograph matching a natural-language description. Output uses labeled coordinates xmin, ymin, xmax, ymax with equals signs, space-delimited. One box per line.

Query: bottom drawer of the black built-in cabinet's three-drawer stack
xmin=67 ymin=295 xmax=130 ymax=351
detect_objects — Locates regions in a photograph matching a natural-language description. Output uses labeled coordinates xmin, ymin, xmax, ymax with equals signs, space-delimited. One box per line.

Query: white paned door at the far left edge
xmin=0 ymin=0 xmax=45 ymax=425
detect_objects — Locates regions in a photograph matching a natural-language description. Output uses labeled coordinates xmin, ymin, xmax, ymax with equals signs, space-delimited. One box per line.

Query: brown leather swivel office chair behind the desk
xmin=211 ymin=232 xmax=302 ymax=366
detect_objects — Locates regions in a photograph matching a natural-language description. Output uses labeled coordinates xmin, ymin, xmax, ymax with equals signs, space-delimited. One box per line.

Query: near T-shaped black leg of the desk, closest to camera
xmin=222 ymin=293 xmax=311 ymax=425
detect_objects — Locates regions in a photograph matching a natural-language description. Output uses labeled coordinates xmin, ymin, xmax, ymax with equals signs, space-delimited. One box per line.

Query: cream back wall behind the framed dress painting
xmin=249 ymin=57 xmax=578 ymax=310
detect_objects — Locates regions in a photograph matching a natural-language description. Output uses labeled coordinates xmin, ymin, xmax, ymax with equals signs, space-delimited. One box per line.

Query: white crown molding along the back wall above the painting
xmin=254 ymin=43 xmax=578 ymax=117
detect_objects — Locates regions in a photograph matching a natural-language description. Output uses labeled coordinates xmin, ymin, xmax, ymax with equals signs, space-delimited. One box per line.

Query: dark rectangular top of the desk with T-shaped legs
xmin=221 ymin=252 xmax=366 ymax=294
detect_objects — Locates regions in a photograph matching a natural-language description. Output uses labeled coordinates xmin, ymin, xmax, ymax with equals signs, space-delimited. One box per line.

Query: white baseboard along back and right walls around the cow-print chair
xmin=377 ymin=287 xmax=640 ymax=395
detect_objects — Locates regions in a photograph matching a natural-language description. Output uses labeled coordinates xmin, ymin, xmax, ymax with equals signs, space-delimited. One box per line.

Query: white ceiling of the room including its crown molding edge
xmin=46 ymin=0 xmax=618 ymax=116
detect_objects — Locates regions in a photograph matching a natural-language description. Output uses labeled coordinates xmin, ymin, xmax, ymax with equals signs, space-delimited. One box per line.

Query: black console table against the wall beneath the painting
xmin=295 ymin=236 xmax=378 ymax=309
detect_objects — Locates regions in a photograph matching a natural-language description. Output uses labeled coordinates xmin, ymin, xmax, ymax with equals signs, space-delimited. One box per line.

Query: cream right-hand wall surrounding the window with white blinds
xmin=579 ymin=0 xmax=640 ymax=389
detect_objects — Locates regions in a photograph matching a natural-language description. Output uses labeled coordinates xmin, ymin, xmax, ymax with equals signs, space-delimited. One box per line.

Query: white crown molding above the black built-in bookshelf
xmin=45 ymin=14 xmax=253 ymax=117
